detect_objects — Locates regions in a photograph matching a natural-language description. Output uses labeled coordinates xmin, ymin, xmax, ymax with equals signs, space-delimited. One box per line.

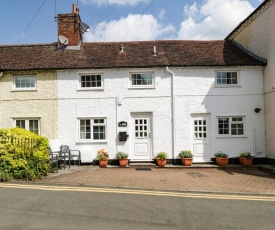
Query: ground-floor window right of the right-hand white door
xmin=218 ymin=117 xmax=244 ymax=136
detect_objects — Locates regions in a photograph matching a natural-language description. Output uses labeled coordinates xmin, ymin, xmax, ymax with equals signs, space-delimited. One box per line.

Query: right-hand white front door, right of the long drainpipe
xmin=192 ymin=114 xmax=211 ymax=162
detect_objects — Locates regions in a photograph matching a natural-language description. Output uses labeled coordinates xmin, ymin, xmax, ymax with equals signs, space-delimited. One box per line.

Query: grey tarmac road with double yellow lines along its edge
xmin=0 ymin=183 xmax=275 ymax=230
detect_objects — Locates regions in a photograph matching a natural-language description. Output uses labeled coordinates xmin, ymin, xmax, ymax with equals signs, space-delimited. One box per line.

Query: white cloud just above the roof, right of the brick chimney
xmin=84 ymin=14 xmax=175 ymax=42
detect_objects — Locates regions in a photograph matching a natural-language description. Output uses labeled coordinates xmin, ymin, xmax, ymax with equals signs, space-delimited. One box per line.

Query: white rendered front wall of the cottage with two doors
xmin=57 ymin=67 xmax=265 ymax=162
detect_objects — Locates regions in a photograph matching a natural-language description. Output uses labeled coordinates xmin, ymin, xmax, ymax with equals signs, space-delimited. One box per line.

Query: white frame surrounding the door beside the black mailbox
xmin=129 ymin=112 xmax=153 ymax=161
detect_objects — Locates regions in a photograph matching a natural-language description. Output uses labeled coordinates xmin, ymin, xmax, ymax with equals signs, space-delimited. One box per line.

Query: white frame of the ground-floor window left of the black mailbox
xmin=78 ymin=117 xmax=107 ymax=142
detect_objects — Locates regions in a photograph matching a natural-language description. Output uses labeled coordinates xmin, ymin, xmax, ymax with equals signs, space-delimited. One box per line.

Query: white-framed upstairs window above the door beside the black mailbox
xmin=130 ymin=73 xmax=154 ymax=88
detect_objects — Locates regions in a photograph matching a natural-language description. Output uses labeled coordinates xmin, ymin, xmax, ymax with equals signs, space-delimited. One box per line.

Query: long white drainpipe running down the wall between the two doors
xmin=166 ymin=66 xmax=175 ymax=164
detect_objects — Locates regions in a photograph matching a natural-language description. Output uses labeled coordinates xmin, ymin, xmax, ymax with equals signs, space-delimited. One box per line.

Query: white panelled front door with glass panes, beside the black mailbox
xmin=131 ymin=113 xmax=152 ymax=161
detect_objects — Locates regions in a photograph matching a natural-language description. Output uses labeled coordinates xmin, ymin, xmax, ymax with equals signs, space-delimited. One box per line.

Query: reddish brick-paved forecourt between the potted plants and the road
xmin=31 ymin=164 xmax=275 ymax=196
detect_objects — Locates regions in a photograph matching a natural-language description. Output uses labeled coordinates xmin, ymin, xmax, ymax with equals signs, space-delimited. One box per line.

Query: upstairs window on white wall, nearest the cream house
xmin=80 ymin=74 xmax=103 ymax=89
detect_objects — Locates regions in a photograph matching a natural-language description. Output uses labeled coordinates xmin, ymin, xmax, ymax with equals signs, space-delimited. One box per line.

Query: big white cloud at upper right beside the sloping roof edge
xmin=178 ymin=0 xmax=254 ymax=40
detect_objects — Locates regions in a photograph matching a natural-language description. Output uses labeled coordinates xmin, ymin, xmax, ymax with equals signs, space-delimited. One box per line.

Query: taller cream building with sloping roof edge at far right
xmin=226 ymin=0 xmax=275 ymax=163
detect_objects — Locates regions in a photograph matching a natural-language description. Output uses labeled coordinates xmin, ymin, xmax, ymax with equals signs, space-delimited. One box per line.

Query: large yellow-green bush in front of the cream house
xmin=0 ymin=128 xmax=50 ymax=181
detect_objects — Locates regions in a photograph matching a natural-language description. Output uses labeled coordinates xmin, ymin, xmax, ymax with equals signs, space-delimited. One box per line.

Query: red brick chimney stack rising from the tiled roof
xmin=57 ymin=5 xmax=82 ymax=46
